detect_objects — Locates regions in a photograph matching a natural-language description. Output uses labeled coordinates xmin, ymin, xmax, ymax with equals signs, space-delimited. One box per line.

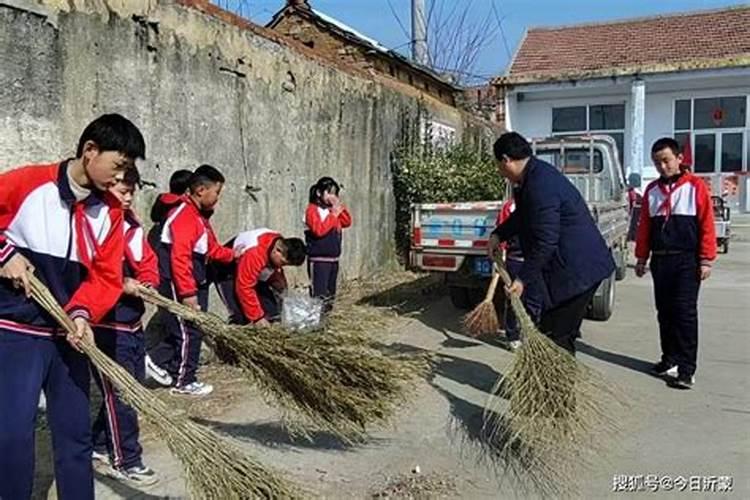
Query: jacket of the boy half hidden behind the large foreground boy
xmin=96 ymin=211 xmax=159 ymax=332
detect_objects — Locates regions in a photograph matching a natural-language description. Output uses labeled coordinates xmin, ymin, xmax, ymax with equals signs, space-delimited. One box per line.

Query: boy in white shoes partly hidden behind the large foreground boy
xmin=93 ymin=169 xmax=159 ymax=486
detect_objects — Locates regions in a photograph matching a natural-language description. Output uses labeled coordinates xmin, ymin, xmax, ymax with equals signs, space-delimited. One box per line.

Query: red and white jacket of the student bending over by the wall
xmin=234 ymin=229 xmax=284 ymax=322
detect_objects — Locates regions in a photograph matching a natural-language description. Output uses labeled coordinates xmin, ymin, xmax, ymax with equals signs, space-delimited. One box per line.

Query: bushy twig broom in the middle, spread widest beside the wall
xmin=140 ymin=287 xmax=426 ymax=443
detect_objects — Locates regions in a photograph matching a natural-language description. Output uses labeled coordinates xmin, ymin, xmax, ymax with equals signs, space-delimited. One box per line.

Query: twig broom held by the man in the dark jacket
xmin=483 ymin=266 xmax=625 ymax=497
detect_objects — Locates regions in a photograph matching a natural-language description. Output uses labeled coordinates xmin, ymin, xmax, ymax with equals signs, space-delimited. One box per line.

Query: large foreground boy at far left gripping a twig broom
xmin=0 ymin=114 xmax=145 ymax=500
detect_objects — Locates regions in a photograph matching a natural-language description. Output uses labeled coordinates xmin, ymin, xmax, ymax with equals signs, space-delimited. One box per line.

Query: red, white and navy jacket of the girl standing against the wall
xmin=305 ymin=203 xmax=352 ymax=262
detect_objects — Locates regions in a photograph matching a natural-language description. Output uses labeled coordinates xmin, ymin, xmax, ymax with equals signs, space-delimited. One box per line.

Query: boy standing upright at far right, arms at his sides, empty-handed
xmin=635 ymin=138 xmax=716 ymax=389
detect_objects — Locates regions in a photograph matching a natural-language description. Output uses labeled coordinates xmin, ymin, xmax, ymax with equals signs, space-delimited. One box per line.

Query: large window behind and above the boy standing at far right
xmin=674 ymin=96 xmax=750 ymax=174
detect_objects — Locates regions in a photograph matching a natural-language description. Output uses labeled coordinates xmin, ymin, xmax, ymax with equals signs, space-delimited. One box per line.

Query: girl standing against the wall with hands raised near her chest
xmin=305 ymin=177 xmax=352 ymax=309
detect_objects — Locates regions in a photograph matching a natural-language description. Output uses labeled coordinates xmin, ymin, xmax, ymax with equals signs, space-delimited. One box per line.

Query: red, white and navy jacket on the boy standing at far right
xmin=635 ymin=172 xmax=716 ymax=264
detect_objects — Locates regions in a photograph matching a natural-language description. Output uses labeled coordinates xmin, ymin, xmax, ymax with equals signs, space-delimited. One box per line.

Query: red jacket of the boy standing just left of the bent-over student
xmin=159 ymin=196 xmax=234 ymax=299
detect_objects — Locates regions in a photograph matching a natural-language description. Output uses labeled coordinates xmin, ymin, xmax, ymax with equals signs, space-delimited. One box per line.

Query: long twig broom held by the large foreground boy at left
xmin=31 ymin=276 xmax=300 ymax=500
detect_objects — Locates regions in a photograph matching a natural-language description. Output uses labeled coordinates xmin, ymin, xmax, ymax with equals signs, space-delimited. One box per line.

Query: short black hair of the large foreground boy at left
xmin=76 ymin=113 xmax=146 ymax=160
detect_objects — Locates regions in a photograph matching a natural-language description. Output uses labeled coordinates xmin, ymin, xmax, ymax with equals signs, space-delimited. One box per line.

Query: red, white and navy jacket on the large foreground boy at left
xmin=0 ymin=161 xmax=124 ymax=336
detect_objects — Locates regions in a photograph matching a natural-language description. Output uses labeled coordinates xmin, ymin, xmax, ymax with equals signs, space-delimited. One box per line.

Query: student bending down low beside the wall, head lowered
xmin=218 ymin=228 xmax=305 ymax=326
